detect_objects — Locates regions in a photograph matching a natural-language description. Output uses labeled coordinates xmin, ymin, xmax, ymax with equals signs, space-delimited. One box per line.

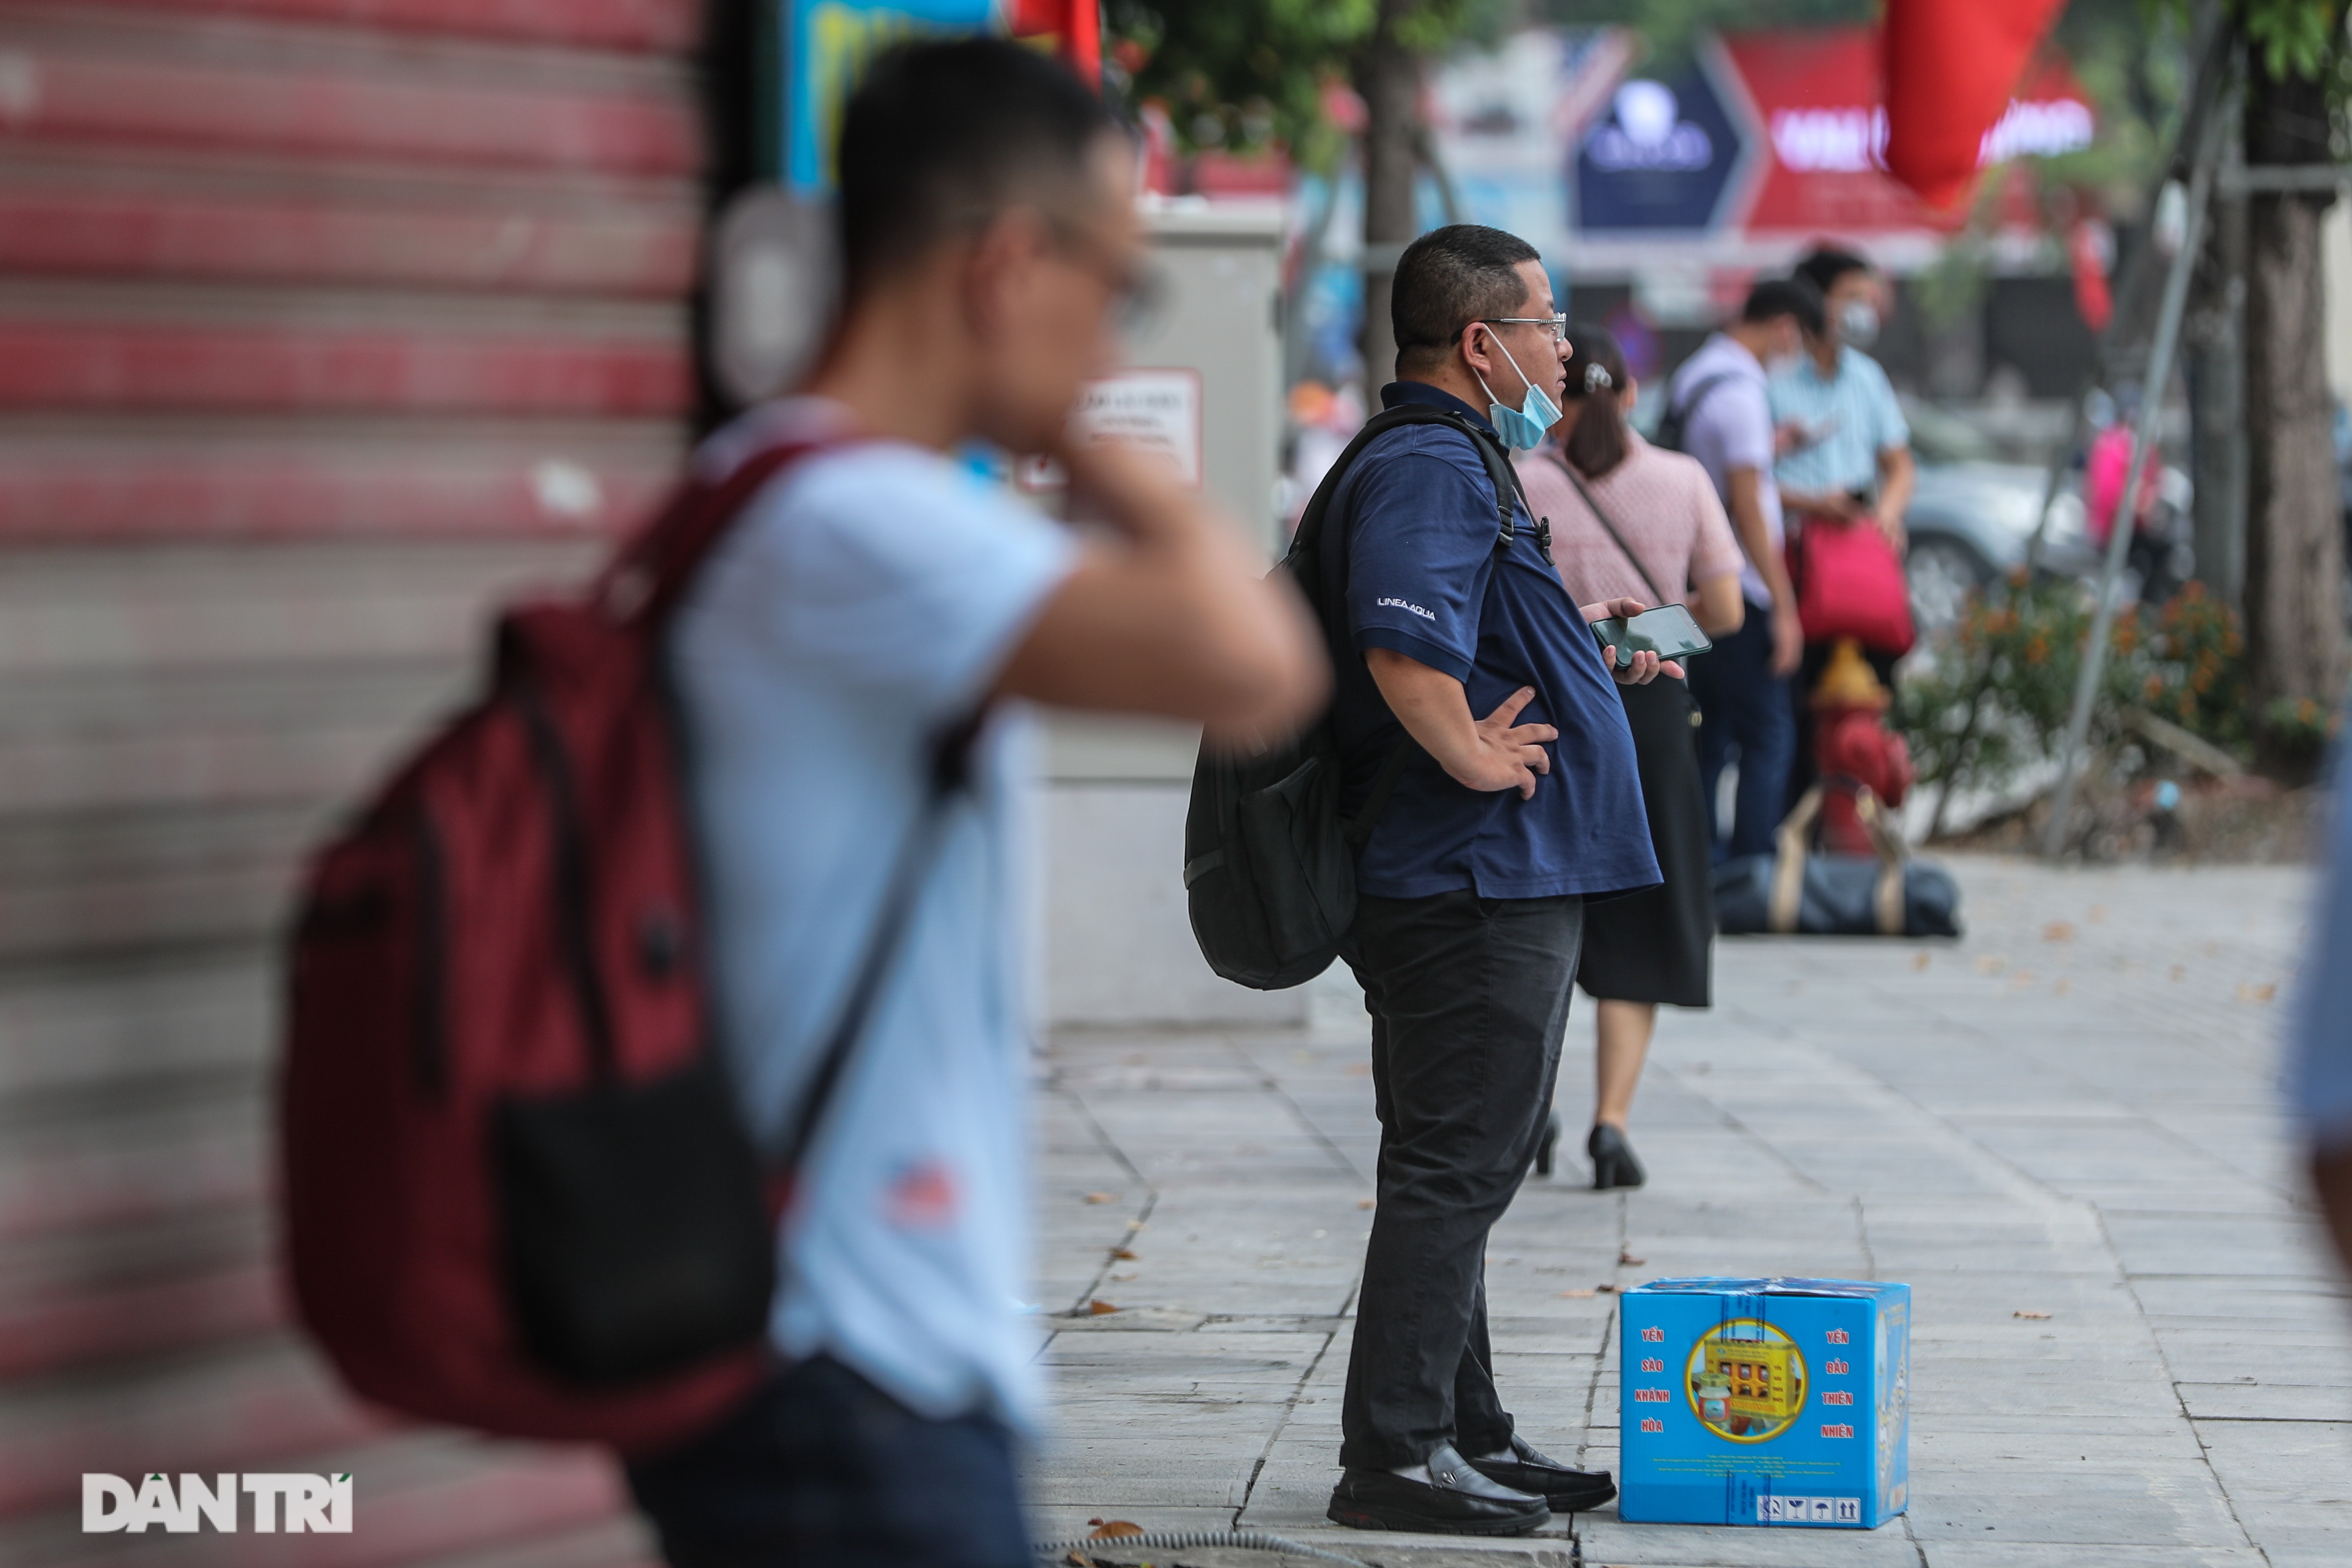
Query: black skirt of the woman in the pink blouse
xmin=1576 ymin=675 xmax=1715 ymax=1006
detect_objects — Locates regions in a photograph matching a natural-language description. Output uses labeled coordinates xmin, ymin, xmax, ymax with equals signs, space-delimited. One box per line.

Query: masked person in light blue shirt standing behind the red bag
xmin=1769 ymin=245 xmax=1915 ymax=804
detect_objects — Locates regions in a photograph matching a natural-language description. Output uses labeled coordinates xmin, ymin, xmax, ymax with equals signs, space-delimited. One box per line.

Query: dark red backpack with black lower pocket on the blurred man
xmin=280 ymin=444 xmax=837 ymax=1451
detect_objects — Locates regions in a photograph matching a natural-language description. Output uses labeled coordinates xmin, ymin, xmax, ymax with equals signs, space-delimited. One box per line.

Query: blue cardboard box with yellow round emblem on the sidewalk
xmin=1618 ymin=1279 xmax=1910 ymax=1530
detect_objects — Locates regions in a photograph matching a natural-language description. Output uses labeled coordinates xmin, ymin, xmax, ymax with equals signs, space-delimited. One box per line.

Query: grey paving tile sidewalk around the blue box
xmin=1032 ymin=861 xmax=2352 ymax=1568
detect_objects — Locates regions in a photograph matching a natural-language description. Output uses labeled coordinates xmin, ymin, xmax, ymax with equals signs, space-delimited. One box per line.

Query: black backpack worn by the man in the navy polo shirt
xmin=1183 ymin=404 xmax=1550 ymax=990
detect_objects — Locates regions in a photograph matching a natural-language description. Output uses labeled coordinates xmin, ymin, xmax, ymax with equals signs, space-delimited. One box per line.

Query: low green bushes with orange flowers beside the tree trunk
xmin=1891 ymin=578 xmax=2246 ymax=790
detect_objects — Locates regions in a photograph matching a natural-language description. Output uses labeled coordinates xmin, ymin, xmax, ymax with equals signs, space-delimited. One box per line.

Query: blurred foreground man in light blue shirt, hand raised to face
xmin=630 ymin=40 xmax=1329 ymax=1568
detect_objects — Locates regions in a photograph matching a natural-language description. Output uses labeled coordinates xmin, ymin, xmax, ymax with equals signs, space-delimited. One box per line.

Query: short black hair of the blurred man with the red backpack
xmin=840 ymin=38 xmax=1117 ymax=294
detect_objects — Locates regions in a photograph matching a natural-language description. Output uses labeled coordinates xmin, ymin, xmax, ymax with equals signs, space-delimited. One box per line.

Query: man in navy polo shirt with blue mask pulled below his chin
xmin=1329 ymin=223 xmax=1679 ymax=1535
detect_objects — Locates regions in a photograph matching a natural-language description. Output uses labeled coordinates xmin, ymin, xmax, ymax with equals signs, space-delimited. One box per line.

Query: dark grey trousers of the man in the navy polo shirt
xmin=1338 ymin=891 xmax=1585 ymax=1469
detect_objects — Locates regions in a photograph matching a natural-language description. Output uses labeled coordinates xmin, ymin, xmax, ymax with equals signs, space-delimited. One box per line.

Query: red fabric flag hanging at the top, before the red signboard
xmin=1887 ymin=0 xmax=2065 ymax=207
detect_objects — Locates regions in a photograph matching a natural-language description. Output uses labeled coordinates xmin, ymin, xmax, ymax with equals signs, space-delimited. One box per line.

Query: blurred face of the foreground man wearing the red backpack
xmin=967 ymin=134 xmax=1143 ymax=451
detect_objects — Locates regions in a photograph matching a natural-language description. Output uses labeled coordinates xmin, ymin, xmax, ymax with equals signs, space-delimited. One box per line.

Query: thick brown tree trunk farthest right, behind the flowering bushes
xmin=2246 ymin=49 xmax=2345 ymax=773
